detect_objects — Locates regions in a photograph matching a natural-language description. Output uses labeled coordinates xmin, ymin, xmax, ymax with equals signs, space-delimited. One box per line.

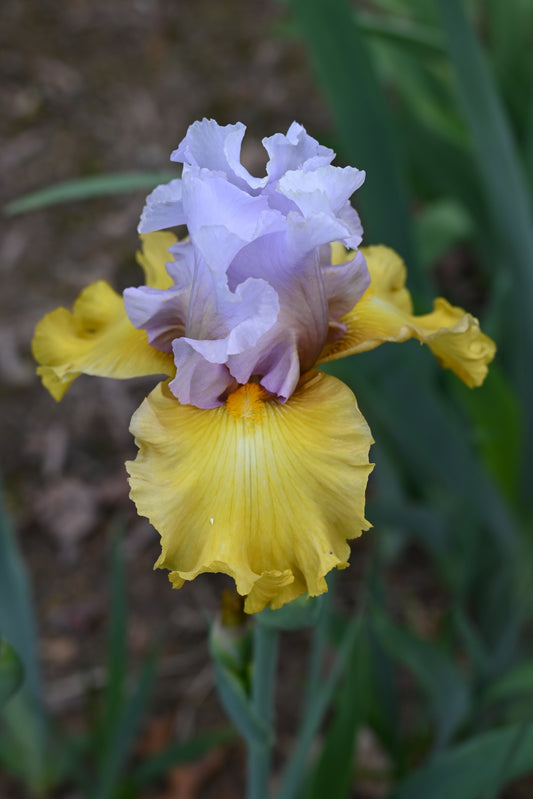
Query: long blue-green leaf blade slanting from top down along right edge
xmin=437 ymin=0 xmax=533 ymax=501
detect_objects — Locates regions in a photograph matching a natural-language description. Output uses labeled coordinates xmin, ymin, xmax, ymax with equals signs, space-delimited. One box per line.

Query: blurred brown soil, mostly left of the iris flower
xmin=0 ymin=0 xmax=528 ymax=799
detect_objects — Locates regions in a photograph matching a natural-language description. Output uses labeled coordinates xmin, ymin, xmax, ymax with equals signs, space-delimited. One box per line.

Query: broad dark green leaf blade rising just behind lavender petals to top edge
xmin=289 ymin=0 xmax=420 ymax=292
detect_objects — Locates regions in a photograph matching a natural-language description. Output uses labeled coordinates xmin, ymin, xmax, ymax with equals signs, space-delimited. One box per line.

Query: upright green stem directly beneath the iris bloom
xmin=247 ymin=620 xmax=279 ymax=799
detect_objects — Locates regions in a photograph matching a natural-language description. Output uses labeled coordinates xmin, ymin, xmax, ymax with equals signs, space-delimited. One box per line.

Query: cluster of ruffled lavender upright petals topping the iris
xmin=131 ymin=119 xmax=369 ymax=408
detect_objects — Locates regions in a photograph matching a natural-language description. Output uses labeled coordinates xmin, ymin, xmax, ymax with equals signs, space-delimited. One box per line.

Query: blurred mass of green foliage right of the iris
xmin=288 ymin=0 xmax=533 ymax=799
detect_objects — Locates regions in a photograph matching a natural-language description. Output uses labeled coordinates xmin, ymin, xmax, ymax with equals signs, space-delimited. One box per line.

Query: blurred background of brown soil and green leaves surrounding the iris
xmin=0 ymin=0 xmax=533 ymax=799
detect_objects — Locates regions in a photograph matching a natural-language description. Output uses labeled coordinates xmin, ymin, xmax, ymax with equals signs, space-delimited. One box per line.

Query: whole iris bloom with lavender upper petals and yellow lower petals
xmin=33 ymin=119 xmax=495 ymax=613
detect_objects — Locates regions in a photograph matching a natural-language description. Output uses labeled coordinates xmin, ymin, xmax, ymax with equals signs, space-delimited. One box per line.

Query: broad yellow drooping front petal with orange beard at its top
xmin=126 ymin=372 xmax=372 ymax=613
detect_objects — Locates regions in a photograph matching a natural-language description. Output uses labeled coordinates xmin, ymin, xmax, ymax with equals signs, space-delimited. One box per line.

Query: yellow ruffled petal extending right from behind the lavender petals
xmin=319 ymin=246 xmax=496 ymax=388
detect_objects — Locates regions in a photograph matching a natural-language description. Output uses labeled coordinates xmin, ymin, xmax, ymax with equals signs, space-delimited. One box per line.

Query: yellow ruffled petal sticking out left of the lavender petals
xmin=32 ymin=280 xmax=174 ymax=400
